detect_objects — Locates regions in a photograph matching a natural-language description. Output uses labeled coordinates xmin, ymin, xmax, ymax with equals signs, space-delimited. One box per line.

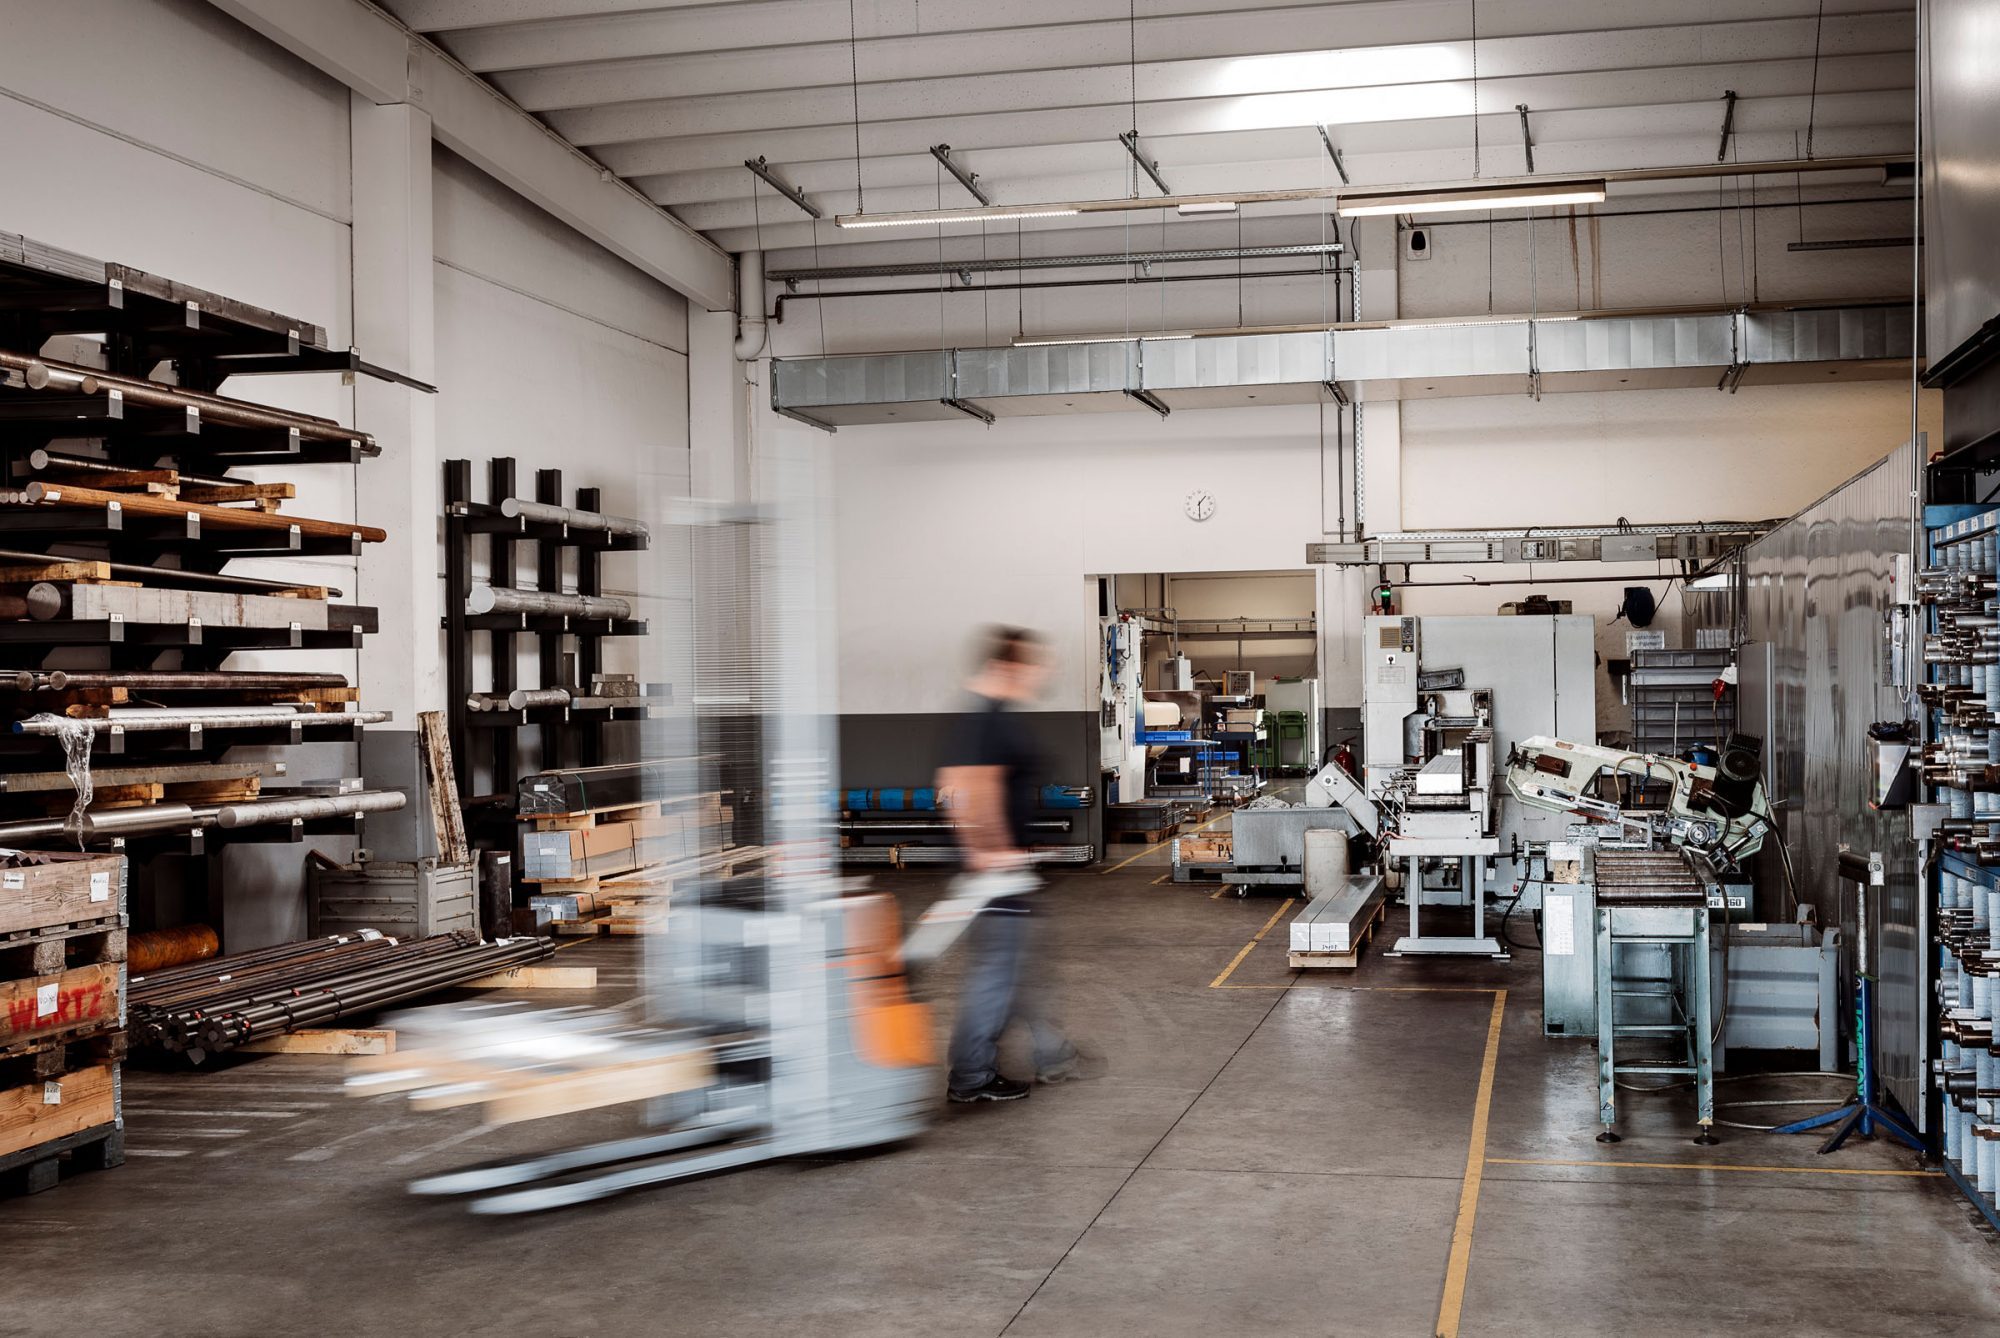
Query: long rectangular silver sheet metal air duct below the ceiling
xmin=772 ymin=302 xmax=1912 ymax=428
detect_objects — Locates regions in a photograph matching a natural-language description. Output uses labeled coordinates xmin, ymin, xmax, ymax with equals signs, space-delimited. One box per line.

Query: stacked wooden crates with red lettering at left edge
xmin=0 ymin=852 xmax=126 ymax=1194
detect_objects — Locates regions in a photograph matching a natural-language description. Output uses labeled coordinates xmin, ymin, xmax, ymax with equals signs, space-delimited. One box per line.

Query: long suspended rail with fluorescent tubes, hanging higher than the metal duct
xmin=828 ymin=154 xmax=1914 ymax=228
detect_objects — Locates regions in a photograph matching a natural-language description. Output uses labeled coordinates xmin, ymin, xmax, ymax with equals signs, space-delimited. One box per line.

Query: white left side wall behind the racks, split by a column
xmin=0 ymin=0 xmax=688 ymax=948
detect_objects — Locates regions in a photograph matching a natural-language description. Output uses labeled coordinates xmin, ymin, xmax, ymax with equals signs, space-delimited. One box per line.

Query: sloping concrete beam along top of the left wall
xmin=210 ymin=0 xmax=734 ymax=310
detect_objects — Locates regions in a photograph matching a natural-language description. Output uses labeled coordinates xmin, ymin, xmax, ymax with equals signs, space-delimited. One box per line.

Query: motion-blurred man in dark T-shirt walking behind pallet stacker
xmin=938 ymin=628 xmax=1078 ymax=1102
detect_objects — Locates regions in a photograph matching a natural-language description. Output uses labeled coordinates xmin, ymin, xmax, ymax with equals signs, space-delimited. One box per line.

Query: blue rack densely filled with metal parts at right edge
xmin=1916 ymin=508 xmax=2000 ymax=1214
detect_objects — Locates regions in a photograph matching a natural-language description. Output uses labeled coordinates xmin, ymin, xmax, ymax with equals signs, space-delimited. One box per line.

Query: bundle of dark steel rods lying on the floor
xmin=130 ymin=930 xmax=554 ymax=1058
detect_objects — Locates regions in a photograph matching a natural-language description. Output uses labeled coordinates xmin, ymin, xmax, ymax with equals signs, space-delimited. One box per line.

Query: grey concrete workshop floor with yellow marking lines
xmin=0 ymin=828 xmax=2000 ymax=1338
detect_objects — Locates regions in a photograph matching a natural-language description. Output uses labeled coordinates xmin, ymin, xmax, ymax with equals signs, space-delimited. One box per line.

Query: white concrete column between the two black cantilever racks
xmin=350 ymin=94 xmax=444 ymax=860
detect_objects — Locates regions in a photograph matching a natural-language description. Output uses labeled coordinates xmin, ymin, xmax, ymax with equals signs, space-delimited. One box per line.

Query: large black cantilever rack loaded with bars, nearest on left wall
xmin=0 ymin=234 xmax=404 ymax=930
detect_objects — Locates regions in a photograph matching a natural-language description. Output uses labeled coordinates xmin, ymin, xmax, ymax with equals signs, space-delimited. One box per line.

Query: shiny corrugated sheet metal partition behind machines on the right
xmin=1744 ymin=444 xmax=1924 ymax=1118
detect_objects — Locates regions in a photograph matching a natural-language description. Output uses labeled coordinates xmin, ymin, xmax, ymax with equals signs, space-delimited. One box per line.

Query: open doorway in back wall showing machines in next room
xmin=1098 ymin=570 xmax=1328 ymax=830
